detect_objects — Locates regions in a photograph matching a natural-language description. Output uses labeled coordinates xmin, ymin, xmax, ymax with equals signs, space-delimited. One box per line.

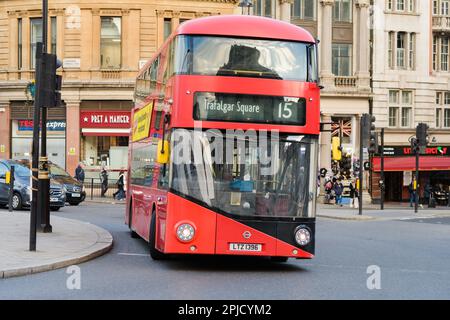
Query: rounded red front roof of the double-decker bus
xmin=175 ymin=15 xmax=316 ymax=42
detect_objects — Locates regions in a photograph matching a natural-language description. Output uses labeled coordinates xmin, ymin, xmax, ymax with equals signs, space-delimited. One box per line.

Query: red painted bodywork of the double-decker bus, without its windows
xmin=125 ymin=15 xmax=320 ymax=259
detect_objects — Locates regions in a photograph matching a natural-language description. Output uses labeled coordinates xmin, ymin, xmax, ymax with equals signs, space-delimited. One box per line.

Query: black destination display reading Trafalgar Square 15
xmin=194 ymin=92 xmax=306 ymax=126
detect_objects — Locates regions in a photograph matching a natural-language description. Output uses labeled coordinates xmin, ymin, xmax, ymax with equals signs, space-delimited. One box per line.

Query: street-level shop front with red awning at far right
xmin=371 ymin=146 xmax=450 ymax=205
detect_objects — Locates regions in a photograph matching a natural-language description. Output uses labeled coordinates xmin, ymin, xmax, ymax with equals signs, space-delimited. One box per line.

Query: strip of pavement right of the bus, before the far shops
xmin=317 ymin=204 xmax=450 ymax=221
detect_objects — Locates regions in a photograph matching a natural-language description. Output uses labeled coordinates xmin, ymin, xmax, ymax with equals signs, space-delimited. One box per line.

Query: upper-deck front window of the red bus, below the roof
xmin=175 ymin=35 xmax=317 ymax=82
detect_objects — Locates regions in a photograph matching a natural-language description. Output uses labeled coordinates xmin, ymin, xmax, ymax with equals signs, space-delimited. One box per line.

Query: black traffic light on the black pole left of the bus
xmin=39 ymin=53 xmax=62 ymax=107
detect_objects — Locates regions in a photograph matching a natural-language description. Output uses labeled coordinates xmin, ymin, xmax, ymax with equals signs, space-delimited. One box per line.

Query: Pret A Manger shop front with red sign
xmin=80 ymin=110 xmax=131 ymax=175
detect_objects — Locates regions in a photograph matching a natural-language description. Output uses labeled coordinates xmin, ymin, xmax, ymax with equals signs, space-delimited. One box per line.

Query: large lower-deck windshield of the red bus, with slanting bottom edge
xmin=170 ymin=129 xmax=317 ymax=217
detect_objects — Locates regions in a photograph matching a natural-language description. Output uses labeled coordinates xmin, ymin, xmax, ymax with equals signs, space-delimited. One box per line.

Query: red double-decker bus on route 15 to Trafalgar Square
xmin=125 ymin=15 xmax=320 ymax=262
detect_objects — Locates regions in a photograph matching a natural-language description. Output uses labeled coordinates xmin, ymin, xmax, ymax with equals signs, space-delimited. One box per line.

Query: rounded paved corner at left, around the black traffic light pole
xmin=0 ymin=210 xmax=113 ymax=279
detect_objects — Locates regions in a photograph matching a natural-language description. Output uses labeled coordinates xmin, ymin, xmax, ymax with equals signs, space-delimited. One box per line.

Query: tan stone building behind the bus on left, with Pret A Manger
xmin=0 ymin=0 xmax=239 ymax=173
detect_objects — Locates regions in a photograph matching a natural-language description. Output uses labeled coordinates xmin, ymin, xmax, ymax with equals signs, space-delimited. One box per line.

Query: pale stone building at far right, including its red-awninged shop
xmin=372 ymin=0 xmax=450 ymax=201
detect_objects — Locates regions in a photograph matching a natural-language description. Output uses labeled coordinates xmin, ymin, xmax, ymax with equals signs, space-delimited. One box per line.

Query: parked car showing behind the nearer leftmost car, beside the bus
xmin=18 ymin=159 xmax=86 ymax=206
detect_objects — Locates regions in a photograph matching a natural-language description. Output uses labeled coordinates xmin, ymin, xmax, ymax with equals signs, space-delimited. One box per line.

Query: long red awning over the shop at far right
xmin=373 ymin=157 xmax=450 ymax=171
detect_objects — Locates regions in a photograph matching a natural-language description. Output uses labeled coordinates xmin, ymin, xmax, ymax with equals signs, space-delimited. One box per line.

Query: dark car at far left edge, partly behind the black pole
xmin=0 ymin=160 xmax=66 ymax=211
